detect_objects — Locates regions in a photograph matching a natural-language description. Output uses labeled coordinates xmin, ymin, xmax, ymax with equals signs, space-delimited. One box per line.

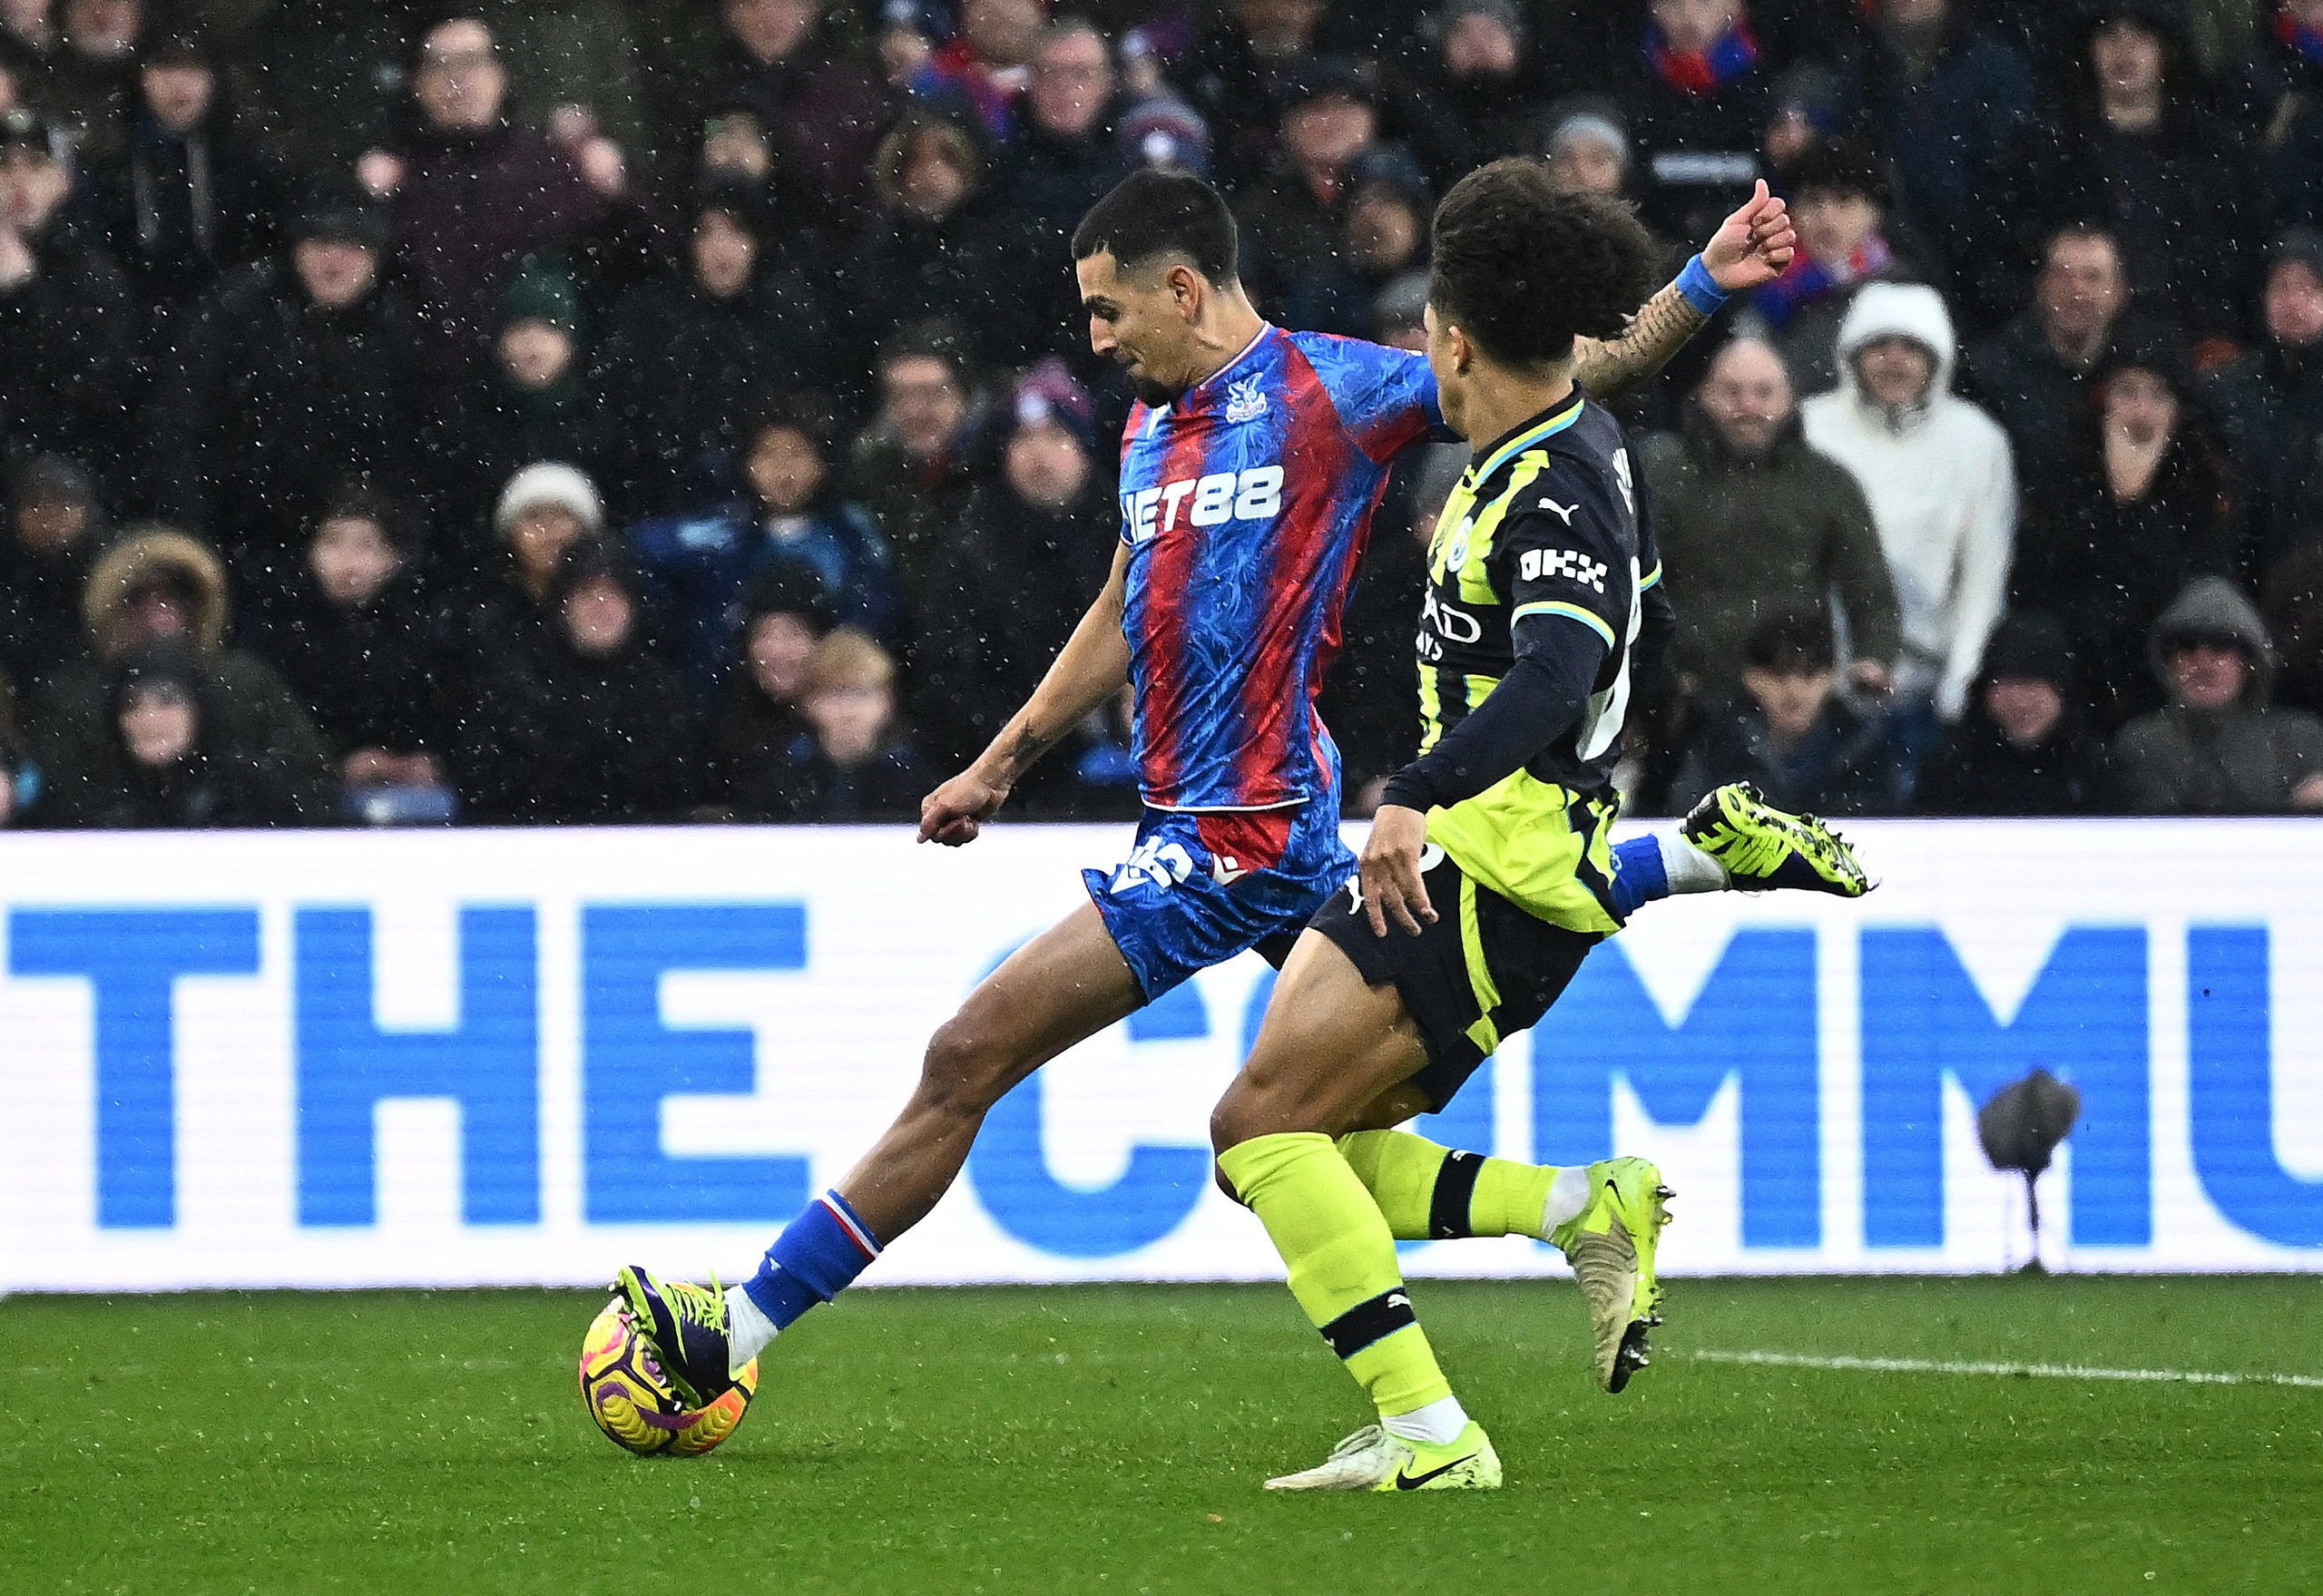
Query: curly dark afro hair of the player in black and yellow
xmin=1428 ymin=156 xmax=1659 ymax=365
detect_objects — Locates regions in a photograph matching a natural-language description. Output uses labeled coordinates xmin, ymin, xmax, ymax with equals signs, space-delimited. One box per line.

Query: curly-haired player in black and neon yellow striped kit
xmin=1211 ymin=161 xmax=1863 ymax=1492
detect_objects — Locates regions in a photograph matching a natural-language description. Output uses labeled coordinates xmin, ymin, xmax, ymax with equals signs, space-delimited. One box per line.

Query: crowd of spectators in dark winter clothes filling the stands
xmin=0 ymin=0 xmax=2323 ymax=827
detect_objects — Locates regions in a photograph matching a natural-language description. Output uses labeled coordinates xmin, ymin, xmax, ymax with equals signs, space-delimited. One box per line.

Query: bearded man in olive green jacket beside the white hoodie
xmin=1638 ymin=339 xmax=1898 ymax=697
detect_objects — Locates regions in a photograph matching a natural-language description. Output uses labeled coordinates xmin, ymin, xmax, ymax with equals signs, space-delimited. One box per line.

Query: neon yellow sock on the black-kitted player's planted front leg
xmin=1217 ymin=1131 xmax=1452 ymax=1415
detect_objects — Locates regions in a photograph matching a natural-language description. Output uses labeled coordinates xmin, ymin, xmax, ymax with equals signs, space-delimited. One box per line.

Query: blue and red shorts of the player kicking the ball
xmin=1080 ymin=804 xmax=1354 ymax=1004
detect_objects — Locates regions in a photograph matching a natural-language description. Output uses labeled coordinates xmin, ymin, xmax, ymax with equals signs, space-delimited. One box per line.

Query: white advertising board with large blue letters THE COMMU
xmin=0 ymin=822 xmax=2323 ymax=1289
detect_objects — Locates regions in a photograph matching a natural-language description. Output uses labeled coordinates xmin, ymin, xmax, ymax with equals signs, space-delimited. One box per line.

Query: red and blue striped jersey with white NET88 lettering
xmin=1122 ymin=325 xmax=1443 ymax=808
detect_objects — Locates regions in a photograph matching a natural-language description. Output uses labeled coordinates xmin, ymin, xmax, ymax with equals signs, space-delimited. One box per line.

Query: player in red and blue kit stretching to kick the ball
xmin=618 ymin=171 xmax=1848 ymax=1440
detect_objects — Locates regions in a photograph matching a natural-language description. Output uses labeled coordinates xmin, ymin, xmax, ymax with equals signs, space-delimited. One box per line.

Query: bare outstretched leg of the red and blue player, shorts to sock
xmin=838 ymin=904 xmax=1145 ymax=1243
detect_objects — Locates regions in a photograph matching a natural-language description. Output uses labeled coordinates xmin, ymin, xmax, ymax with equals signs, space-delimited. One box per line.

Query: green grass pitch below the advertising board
xmin=0 ymin=1278 xmax=2323 ymax=1596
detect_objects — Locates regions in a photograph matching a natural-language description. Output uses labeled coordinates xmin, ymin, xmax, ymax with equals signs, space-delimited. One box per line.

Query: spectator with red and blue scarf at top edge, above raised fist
xmin=1614 ymin=0 xmax=1772 ymax=240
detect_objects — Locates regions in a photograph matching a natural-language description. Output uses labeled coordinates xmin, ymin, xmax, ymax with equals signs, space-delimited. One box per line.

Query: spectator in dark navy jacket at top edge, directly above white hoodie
xmin=1866 ymin=0 xmax=2040 ymax=274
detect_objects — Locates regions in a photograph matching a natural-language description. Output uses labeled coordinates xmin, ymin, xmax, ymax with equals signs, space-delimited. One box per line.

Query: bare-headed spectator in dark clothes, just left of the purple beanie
xmin=848 ymin=323 xmax=980 ymax=592
